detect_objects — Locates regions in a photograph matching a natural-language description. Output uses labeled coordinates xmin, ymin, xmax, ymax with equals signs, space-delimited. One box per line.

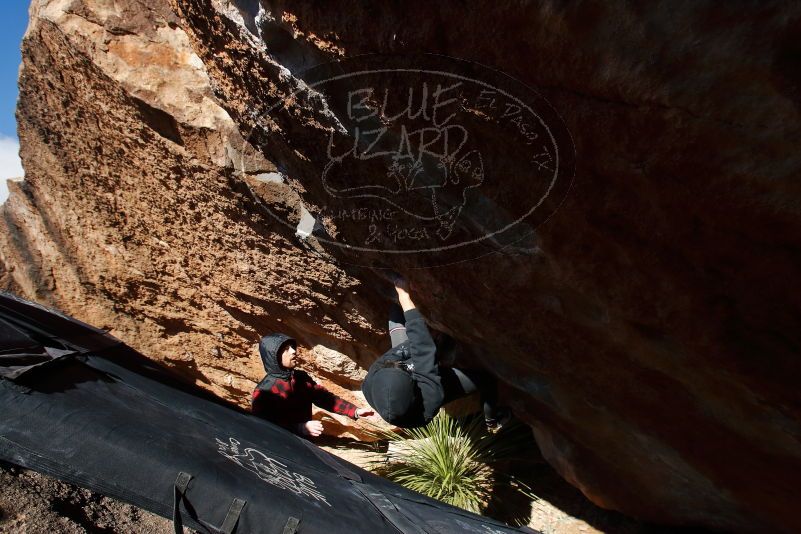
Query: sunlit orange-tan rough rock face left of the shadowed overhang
xmin=0 ymin=1 xmax=382 ymax=440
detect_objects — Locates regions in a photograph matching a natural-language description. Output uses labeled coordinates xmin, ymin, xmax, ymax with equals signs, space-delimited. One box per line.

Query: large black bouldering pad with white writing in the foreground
xmin=0 ymin=293 xmax=532 ymax=534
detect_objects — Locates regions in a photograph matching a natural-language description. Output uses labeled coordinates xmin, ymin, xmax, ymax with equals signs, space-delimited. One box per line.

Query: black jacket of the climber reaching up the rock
xmin=362 ymin=309 xmax=445 ymax=428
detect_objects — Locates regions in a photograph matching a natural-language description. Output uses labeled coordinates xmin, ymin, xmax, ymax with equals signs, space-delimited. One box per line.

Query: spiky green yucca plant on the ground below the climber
xmin=371 ymin=411 xmax=536 ymax=513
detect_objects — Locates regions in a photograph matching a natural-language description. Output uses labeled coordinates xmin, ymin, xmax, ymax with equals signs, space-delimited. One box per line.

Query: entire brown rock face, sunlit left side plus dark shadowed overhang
xmin=0 ymin=0 xmax=801 ymax=532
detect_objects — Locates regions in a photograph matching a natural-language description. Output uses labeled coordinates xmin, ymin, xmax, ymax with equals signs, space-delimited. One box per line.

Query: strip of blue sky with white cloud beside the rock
xmin=0 ymin=0 xmax=29 ymax=202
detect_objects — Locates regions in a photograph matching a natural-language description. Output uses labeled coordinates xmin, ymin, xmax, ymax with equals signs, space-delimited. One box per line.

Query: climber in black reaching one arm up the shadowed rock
xmin=362 ymin=277 xmax=511 ymax=432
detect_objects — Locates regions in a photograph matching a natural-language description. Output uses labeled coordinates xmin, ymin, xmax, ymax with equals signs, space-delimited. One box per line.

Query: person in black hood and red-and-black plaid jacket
xmin=251 ymin=334 xmax=373 ymax=437
